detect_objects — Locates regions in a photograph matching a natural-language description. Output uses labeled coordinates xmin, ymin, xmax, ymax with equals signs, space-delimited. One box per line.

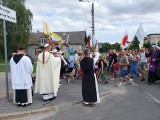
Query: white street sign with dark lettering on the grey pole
xmin=0 ymin=5 xmax=17 ymax=23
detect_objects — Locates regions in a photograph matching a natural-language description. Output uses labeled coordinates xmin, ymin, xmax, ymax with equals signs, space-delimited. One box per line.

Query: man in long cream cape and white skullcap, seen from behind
xmin=35 ymin=44 xmax=61 ymax=102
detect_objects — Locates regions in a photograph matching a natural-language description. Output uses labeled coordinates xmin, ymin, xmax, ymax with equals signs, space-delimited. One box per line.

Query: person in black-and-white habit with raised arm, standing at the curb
xmin=80 ymin=49 xmax=100 ymax=107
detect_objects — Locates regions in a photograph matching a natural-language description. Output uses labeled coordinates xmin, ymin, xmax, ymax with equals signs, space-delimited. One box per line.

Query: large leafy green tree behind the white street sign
xmin=0 ymin=0 xmax=33 ymax=59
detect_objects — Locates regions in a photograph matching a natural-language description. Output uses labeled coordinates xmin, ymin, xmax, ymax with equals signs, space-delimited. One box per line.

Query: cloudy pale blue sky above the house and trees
xmin=25 ymin=0 xmax=160 ymax=44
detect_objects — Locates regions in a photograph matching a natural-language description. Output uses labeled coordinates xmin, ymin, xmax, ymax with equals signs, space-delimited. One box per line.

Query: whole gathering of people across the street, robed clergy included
xmin=10 ymin=44 xmax=160 ymax=107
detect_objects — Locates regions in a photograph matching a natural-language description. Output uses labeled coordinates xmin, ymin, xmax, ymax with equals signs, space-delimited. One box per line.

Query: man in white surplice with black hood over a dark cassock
xmin=10 ymin=46 xmax=33 ymax=107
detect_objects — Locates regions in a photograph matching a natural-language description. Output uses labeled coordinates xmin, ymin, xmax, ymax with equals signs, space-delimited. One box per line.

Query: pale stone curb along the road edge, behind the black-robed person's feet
xmin=0 ymin=91 xmax=112 ymax=120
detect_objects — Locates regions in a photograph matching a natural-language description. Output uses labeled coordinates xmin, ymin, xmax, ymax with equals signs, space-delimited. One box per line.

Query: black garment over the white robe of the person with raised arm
xmin=80 ymin=57 xmax=98 ymax=102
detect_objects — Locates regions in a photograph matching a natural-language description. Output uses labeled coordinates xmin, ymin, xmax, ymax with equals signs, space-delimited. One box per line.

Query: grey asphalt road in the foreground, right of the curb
xmin=11 ymin=80 xmax=160 ymax=120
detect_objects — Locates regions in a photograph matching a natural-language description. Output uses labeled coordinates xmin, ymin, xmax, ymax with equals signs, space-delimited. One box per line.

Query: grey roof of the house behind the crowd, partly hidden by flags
xmin=29 ymin=31 xmax=86 ymax=45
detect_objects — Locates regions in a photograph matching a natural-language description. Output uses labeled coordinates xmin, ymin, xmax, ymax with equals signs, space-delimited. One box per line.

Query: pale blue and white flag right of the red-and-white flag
xmin=135 ymin=23 xmax=145 ymax=49
